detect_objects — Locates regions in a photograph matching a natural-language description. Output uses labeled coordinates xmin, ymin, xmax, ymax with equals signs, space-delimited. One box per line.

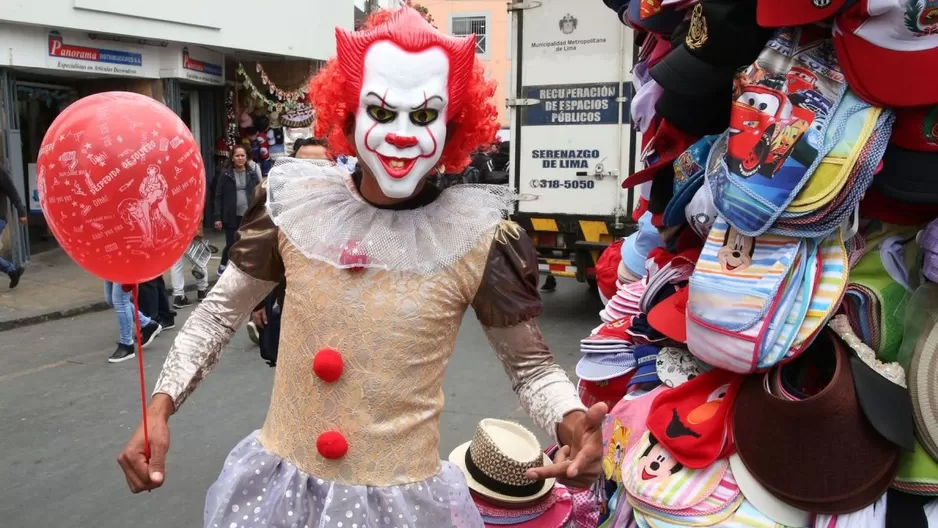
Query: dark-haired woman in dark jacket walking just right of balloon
xmin=213 ymin=145 xmax=261 ymax=275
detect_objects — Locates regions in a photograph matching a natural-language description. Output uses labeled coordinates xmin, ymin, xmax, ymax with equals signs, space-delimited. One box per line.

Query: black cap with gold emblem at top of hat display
xmin=650 ymin=0 xmax=775 ymax=95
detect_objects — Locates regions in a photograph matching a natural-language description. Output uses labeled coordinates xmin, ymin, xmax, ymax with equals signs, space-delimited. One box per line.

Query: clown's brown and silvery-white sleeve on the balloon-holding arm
xmin=153 ymin=182 xmax=284 ymax=409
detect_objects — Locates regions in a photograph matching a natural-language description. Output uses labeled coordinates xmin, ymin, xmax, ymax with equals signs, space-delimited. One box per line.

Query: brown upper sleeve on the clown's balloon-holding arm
xmin=228 ymin=180 xmax=284 ymax=282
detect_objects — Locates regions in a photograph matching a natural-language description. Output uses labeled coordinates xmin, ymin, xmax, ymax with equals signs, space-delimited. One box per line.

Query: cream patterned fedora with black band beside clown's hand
xmin=449 ymin=418 xmax=555 ymax=504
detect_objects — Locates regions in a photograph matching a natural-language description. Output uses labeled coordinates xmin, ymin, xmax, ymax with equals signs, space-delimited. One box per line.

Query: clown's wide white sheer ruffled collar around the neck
xmin=267 ymin=158 xmax=514 ymax=274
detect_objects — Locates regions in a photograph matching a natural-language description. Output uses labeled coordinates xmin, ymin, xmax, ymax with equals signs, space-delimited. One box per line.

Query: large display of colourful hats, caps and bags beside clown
xmin=592 ymin=0 xmax=938 ymax=528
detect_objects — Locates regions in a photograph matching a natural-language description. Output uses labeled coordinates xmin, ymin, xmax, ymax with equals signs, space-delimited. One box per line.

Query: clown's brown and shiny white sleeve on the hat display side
xmin=472 ymin=222 xmax=586 ymax=441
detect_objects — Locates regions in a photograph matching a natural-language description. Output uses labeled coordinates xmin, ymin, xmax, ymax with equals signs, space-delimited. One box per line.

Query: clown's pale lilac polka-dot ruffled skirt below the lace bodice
xmin=205 ymin=431 xmax=483 ymax=528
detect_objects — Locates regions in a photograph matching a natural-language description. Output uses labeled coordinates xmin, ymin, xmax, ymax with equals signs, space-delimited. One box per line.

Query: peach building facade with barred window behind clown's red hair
xmin=418 ymin=0 xmax=511 ymax=128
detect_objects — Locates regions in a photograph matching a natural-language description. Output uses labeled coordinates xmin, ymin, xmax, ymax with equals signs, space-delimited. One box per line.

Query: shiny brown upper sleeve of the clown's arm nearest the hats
xmin=472 ymin=222 xmax=543 ymax=328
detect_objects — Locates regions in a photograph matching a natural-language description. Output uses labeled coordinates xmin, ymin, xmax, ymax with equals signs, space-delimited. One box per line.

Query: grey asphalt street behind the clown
xmin=0 ymin=279 xmax=600 ymax=528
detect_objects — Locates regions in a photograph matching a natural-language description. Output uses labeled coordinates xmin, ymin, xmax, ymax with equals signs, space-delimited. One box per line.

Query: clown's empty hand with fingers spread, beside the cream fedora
xmin=527 ymin=403 xmax=609 ymax=488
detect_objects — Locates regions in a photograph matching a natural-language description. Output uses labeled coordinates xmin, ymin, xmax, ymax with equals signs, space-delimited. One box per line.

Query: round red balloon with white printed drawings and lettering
xmin=36 ymin=92 xmax=205 ymax=284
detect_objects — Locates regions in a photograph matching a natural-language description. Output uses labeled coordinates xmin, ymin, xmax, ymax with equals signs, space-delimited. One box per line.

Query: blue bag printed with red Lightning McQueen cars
xmin=707 ymin=26 xmax=846 ymax=236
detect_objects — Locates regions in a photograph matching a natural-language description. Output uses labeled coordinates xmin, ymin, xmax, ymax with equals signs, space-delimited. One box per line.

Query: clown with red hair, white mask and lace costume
xmin=119 ymin=8 xmax=606 ymax=528
